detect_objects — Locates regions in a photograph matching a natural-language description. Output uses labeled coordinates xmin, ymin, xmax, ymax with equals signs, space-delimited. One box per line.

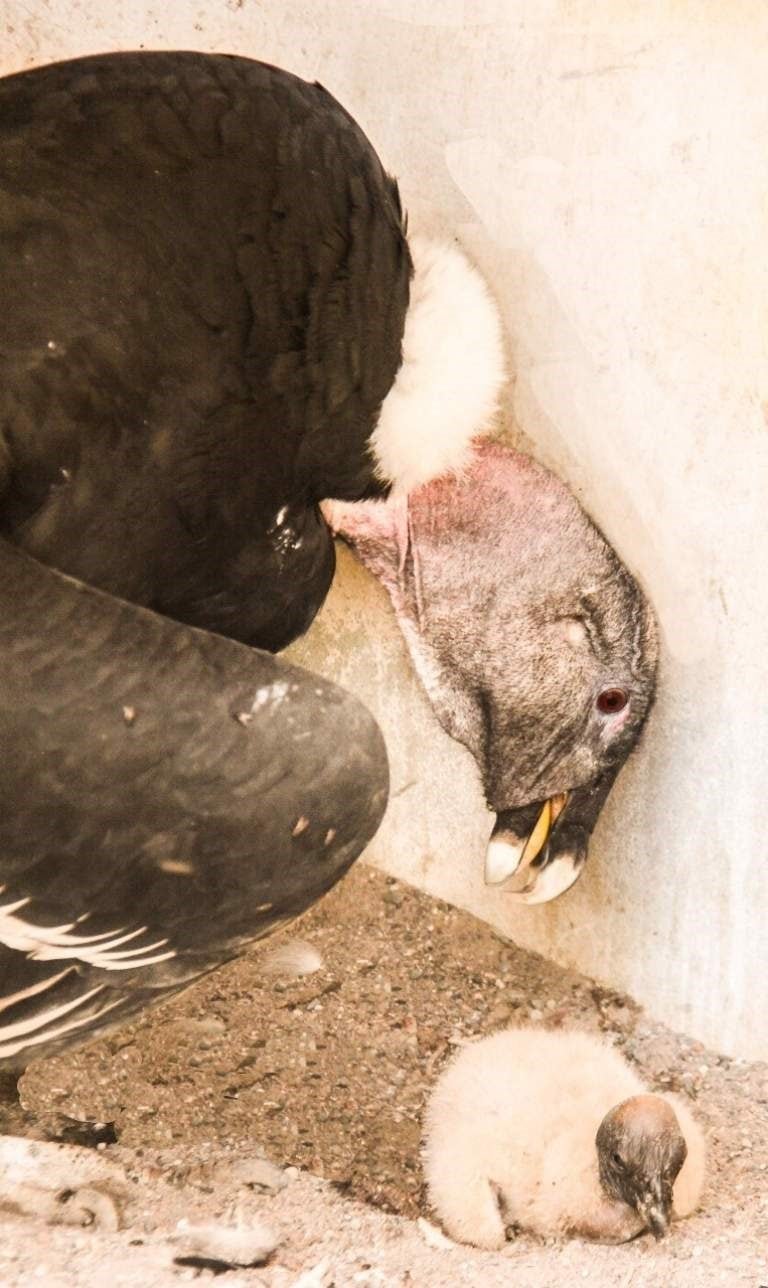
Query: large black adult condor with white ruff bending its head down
xmin=0 ymin=53 xmax=656 ymax=1184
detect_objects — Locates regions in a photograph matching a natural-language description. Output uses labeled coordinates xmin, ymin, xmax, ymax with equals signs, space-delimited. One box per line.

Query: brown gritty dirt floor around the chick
xmin=0 ymin=866 xmax=768 ymax=1288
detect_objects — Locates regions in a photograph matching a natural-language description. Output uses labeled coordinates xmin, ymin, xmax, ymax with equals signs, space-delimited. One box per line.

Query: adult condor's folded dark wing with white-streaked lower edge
xmin=0 ymin=546 xmax=388 ymax=1069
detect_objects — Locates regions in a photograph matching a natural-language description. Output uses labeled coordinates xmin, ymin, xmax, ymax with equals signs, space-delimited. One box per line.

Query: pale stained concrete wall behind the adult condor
xmin=7 ymin=0 xmax=768 ymax=1057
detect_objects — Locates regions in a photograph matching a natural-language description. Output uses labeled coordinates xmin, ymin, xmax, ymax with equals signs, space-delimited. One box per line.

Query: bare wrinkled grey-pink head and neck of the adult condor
xmin=323 ymin=442 xmax=657 ymax=902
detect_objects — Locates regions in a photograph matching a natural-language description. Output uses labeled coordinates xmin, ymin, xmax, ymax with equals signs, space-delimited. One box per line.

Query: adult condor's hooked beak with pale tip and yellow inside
xmin=486 ymin=792 xmax=586 ymax=904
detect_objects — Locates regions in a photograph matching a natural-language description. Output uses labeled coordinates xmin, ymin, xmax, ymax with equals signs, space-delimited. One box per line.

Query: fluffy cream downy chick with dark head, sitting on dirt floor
xmin=424 ymin=1028 xmax=705 ymax=1248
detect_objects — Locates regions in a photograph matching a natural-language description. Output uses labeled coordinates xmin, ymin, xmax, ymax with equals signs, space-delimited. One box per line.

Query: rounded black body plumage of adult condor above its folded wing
xmin=0 ymin=53 xmax=410 ymax=650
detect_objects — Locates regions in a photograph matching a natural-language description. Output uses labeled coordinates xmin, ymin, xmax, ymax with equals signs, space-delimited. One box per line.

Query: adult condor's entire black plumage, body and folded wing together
xmin=0 ymin=53 xmax=402 ymax=1097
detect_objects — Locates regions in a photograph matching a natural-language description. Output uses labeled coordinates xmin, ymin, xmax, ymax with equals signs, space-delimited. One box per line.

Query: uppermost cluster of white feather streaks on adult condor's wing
xmin=0 ymin=886 xmax=175 ymax=970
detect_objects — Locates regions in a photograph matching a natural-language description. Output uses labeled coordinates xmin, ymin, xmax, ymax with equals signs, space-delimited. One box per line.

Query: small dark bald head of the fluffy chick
xmin=595 ymin=1096 xmax=688 ymax=1239
